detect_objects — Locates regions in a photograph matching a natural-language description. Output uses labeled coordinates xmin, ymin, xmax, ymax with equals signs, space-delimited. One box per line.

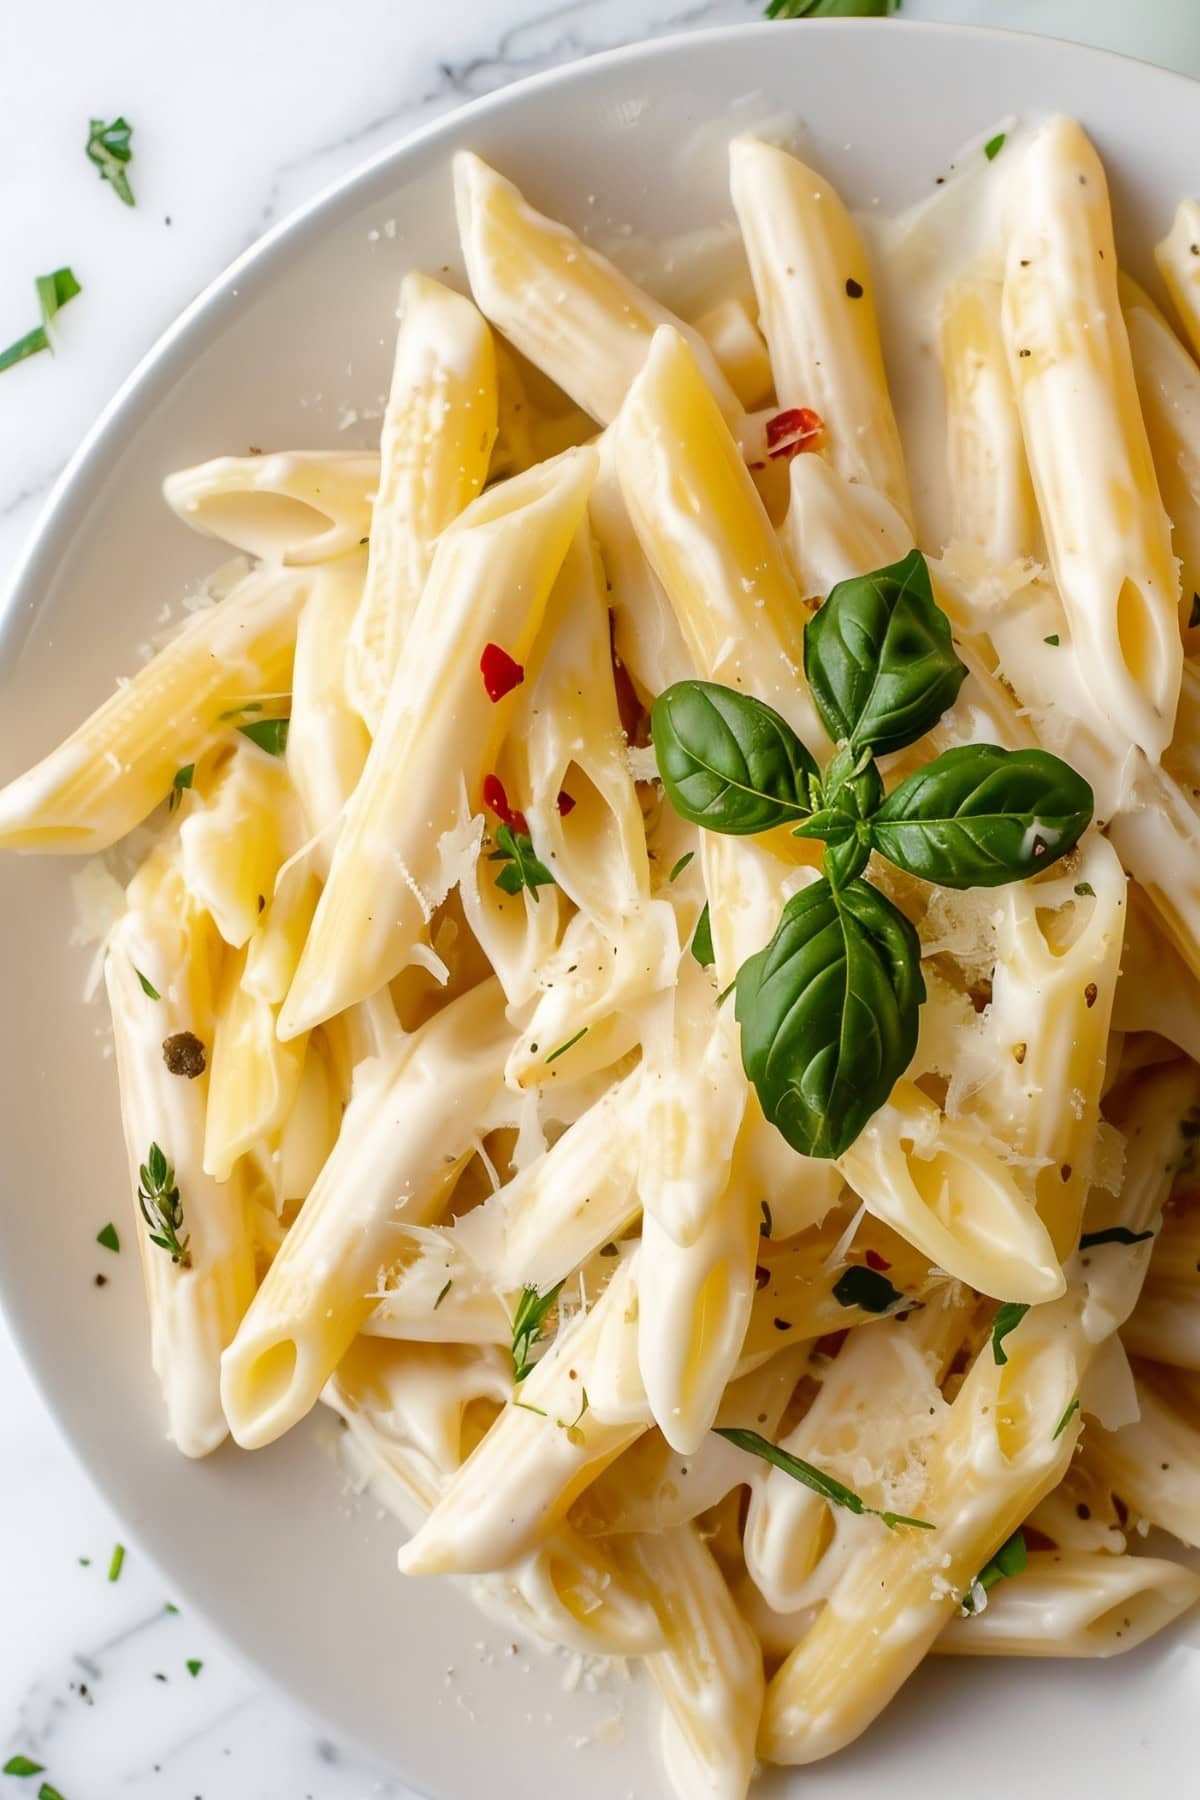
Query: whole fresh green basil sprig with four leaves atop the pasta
xmin=651 ymin=551 xmax=1092 ymax=1157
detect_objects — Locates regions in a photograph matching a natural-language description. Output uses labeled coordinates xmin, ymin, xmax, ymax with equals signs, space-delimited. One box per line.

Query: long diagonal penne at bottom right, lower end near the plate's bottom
xmin=759 ymin=1298 xmax=1081 ymax=1764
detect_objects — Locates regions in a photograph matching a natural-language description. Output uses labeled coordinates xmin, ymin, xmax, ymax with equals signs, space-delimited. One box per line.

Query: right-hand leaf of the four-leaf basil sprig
xmin=871 ymin=743 xmax=1092 ymax=887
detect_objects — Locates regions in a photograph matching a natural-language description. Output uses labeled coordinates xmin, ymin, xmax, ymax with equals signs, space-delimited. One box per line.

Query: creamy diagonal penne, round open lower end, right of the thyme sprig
xmin=221 ymin=983 xmax=511 ymax=1449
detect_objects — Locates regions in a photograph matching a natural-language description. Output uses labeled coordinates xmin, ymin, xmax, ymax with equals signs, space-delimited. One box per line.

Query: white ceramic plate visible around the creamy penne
xmin=0 ymin=22 xmax=1200 ymax=1800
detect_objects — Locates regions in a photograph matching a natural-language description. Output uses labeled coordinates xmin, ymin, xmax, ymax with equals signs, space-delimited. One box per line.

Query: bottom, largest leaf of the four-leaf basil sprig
xmin=736 ymin=880 xmax=925 ymax=1157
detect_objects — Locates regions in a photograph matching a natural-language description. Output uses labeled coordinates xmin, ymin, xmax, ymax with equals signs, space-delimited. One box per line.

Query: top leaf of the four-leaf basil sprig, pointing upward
xmin=804 ymin=551 xmax=966 ymax=756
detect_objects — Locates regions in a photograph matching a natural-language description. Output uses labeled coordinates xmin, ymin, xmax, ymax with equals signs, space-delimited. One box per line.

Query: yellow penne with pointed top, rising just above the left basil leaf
xmin=617 ymin=328 xmax=826 ymax=751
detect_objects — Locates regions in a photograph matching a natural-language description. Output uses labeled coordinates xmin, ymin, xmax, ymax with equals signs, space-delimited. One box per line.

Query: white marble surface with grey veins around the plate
xmin=0 ymin=0 xmax=1200 ymax=1800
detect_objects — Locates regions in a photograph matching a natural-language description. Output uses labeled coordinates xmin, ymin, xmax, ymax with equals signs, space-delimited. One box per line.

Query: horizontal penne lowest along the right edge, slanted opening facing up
xmin=934 ymin=1550 xmax=1200 ymax=1656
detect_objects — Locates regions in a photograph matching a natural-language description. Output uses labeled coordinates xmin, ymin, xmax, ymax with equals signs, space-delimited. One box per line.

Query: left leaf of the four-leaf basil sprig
xmin=649 ymin=680 xmax=817 ymax=837
